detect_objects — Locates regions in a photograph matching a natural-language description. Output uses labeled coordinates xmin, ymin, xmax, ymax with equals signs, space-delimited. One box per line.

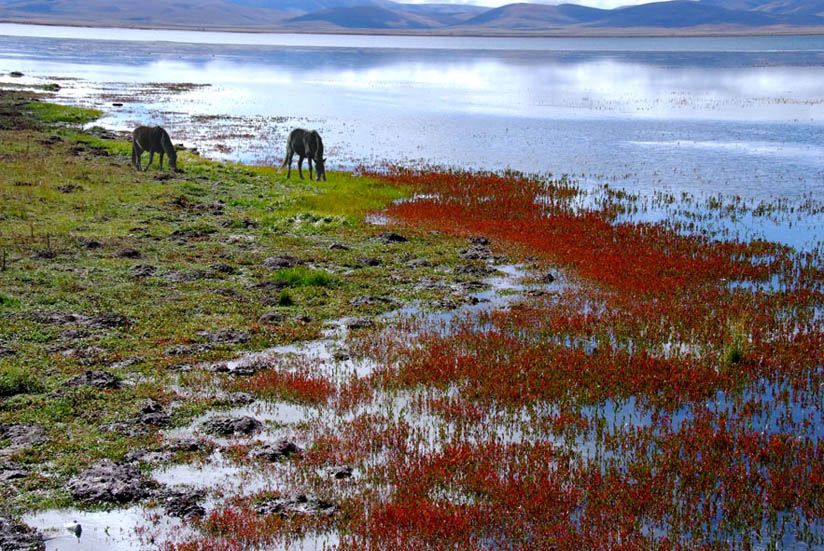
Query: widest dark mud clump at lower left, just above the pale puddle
xmin=67 ymin=459 xmax=156 ymax=503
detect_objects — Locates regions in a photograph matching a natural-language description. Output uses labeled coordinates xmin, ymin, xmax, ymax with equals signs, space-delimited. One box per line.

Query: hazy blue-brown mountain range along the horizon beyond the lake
xmin=0 ymin=0 xmax=824 ymax=35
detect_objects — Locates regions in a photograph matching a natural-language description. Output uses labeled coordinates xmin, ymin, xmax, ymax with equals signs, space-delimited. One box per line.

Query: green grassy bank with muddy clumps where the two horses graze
xmin=0 ymin=91 xmax=482 ymax=511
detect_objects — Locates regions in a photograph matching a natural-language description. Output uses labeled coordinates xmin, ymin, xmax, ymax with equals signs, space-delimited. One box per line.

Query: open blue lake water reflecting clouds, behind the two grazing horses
xmin=0 ymin=25 xmax=824 ymax=245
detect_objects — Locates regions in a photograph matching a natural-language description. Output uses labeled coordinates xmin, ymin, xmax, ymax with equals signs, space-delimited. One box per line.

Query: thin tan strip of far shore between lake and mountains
xmin=0 ymin=18 xmax=824 ymax=38
